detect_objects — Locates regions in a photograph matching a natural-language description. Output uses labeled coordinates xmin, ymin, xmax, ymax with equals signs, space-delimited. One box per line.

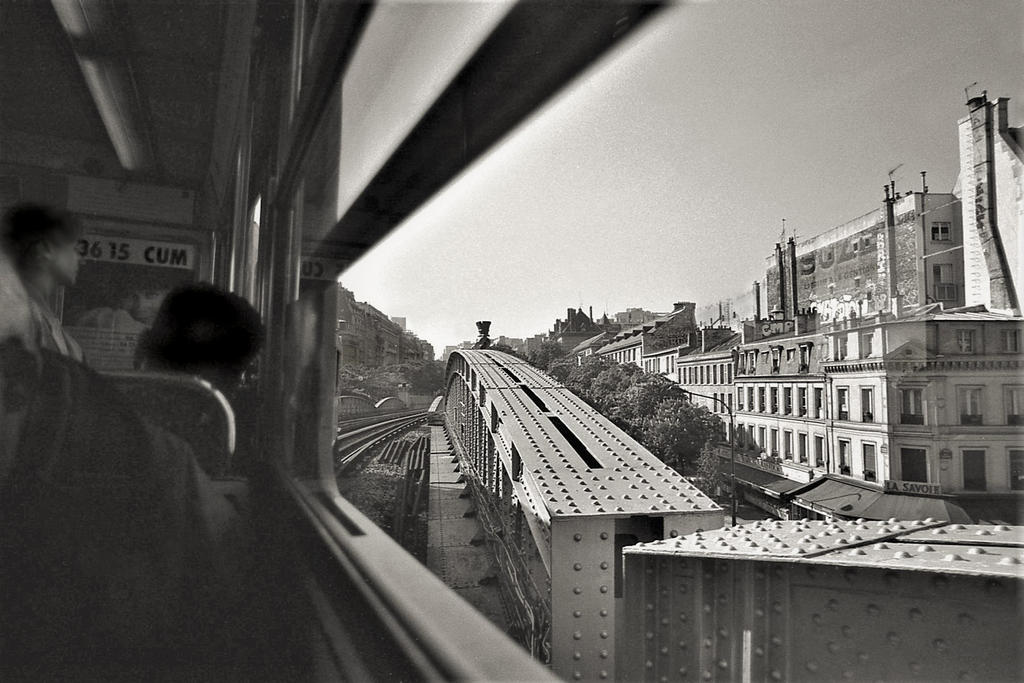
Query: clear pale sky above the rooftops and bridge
xmin=341 ymin=0 xmax=1024 ymax=355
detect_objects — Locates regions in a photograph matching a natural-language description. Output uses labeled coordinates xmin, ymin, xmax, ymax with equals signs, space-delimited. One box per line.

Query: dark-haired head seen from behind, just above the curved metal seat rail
xmin=139 ymin=283 xmax=263 ymax=390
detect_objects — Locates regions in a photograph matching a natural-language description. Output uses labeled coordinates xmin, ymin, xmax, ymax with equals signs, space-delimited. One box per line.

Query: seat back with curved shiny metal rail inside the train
xmin=106 ymin=373 xmax=236 ymax=477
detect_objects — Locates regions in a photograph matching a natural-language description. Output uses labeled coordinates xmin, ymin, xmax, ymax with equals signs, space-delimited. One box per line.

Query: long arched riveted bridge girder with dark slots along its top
xmin=445 ymin=350 xmax=723 ymax=680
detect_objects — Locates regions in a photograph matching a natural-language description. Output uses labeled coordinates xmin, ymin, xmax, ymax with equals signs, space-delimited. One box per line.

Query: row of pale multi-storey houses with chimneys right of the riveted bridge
xmin=573 ymin=92 xmax=1024 ymax=522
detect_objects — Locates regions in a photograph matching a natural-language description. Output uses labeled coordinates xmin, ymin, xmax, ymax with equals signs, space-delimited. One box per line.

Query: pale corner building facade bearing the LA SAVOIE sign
xmin=825 ymin=306 xmax=1024 ymax=520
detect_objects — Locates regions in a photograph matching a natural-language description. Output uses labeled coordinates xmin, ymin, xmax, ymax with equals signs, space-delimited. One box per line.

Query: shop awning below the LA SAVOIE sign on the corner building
xmin=793 ymin=476 xmax=972 ymax=523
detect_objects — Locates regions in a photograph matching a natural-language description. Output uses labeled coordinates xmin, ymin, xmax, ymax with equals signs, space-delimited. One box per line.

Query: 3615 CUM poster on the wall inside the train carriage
xmin=63 ymin=232 xmax=199 ymax=372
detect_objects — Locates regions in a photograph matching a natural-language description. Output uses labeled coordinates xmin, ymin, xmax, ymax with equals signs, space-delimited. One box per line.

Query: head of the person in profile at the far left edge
xmin=3 ymin=204 xmax=82 ymax=286
